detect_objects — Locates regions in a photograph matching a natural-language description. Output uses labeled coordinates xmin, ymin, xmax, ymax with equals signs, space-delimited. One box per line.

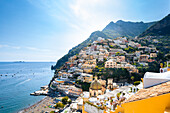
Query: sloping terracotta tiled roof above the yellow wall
xmin=125 ymin=81 xmax=170 ymax=103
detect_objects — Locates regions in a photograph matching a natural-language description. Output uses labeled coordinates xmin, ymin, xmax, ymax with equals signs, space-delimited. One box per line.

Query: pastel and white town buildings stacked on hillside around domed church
xmin=43 ymin=37 xmax=170 ymax=113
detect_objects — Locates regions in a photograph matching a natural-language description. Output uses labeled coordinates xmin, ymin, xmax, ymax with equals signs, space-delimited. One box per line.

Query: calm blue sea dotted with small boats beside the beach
xmin=0 ymin=62 xmax=55 ymax=113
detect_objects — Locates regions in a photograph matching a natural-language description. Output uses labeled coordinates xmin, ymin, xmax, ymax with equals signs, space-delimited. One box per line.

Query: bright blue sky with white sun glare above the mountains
xmin=0 ymin=0 xmax=170 ymax=62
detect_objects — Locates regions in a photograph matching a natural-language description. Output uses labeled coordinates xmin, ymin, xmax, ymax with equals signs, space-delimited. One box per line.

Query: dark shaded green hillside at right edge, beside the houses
xmin=138 ymin=14 xmax=170 ymax=63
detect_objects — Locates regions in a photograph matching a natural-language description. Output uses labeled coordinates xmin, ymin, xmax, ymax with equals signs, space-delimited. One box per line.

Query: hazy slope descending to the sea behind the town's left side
xmin=54 ymin=31 xmax=109 ymax=68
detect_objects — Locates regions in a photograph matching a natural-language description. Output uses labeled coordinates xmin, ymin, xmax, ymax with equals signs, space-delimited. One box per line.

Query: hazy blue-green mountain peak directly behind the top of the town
xmin=103 ymin=20 xmax=155 ymax=38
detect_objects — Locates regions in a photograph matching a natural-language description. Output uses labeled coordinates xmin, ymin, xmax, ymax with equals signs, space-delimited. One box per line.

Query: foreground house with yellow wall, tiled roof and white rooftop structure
xmin=82 ymin=72 xmax=170 ymax=113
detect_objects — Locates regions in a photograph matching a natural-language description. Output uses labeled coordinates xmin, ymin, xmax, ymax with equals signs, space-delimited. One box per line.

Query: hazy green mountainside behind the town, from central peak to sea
xmin=52 ymin=21 xmax=154 ymax=69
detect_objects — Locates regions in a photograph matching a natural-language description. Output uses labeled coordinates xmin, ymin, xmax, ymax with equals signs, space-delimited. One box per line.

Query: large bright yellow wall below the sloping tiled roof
xmin=122 ymin=93 xmax=170 ymax=113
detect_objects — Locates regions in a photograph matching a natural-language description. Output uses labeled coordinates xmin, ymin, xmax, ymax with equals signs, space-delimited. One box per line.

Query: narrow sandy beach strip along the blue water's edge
xmin=17 ymin=96 xmax=49 ymax=113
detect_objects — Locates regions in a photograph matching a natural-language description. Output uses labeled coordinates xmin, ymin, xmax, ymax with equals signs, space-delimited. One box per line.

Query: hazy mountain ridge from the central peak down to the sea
xmin=54 ymin=20 xmax=158 ymax=69
